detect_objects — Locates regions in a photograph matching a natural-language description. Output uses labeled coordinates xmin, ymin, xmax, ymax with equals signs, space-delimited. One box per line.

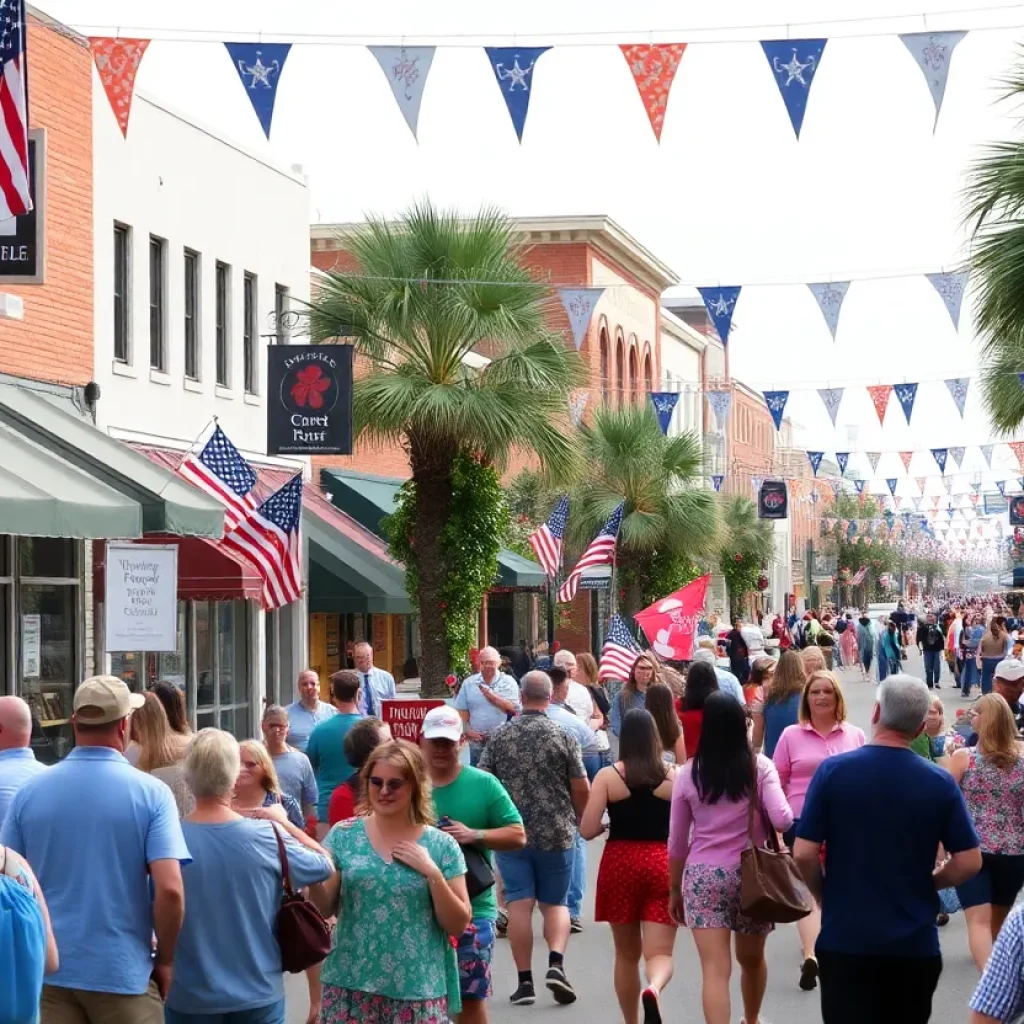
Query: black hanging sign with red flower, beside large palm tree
xmin=266 ymin=345 xmax=352 ymax=455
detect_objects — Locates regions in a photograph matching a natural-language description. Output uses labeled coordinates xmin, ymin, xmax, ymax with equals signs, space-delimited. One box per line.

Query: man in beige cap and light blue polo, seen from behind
xmin=0 ymin=676 xmax=190 ymax=1024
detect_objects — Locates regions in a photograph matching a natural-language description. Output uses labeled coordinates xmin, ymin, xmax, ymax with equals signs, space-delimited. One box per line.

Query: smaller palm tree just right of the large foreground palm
xmin=569 ymin=403 xmax=719 ymax=611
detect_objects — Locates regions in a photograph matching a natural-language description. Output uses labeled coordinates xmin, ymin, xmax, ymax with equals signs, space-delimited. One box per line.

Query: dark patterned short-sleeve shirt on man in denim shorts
xmin=478 ymin=711 xmax=587 ymax=852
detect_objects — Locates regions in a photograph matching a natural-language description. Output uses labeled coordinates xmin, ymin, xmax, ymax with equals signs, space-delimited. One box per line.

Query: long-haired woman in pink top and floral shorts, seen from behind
xmin=669 ymin=693 xmax=793 ymax=1024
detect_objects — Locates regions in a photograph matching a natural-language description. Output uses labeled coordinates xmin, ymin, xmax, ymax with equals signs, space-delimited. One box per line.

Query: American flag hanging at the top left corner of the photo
xmin=0 ymin=0 xmax=32 ymax=220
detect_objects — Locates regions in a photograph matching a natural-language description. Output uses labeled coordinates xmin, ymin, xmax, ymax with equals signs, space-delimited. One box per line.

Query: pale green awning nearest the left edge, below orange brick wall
xmin=0 ymin=422 xmax=142 ymax=540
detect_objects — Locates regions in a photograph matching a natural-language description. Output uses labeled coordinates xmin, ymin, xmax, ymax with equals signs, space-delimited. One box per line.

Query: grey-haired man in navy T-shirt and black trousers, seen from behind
xmin=794 ymin=674 xmax=981 ymax=1024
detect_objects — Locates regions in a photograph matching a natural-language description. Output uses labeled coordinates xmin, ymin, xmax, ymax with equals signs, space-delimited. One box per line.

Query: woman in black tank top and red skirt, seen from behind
xmin=580 ymin=709 xmax=676 ymax=1024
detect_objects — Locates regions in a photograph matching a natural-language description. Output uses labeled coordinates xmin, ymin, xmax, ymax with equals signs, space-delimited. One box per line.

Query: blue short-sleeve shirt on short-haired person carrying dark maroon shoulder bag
xmin=167 ymin=819 xmax=334 ymax=1015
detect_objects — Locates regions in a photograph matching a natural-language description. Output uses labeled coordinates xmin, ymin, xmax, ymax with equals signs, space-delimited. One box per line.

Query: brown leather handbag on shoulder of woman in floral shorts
xmin=739 ymin=756 xmax=814 ymax=925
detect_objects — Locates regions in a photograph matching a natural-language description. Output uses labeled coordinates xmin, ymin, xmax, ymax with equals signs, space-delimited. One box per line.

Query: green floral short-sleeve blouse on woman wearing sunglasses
xmin=321 ymin=818 xmax=466 ymax=999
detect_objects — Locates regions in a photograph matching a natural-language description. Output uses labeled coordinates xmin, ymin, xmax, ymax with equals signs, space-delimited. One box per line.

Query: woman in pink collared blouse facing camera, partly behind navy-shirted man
xmin=772 ymin=672 xmax=865 ymax=992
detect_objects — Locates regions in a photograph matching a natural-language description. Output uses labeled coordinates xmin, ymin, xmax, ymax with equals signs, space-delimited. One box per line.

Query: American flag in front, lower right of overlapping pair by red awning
xmin=220 ymin=473 xmax=302 ymax=609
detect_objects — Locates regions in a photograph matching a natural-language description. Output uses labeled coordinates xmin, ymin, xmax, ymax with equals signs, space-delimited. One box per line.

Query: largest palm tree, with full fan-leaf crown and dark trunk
xmin=308 ymin=202 xmax=579 ymax=692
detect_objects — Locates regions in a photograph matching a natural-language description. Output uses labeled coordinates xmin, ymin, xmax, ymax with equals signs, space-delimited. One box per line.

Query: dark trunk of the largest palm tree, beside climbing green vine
xmin=410 ymin=438 xmax=455 ymax=696
